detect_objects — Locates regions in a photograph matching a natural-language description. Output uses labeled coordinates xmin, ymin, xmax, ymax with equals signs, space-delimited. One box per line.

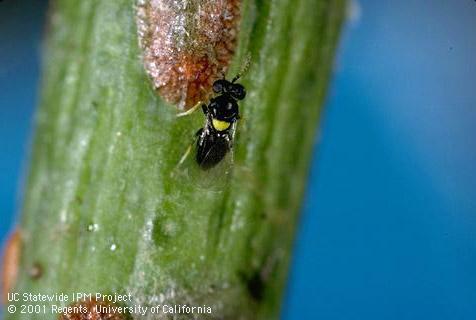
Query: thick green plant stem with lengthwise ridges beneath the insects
xmin=6 ymin=0 xmax=345 ymax=319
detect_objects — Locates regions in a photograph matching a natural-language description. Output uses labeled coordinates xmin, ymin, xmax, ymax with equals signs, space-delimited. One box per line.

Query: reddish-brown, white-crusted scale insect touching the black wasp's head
xmin=137 ymin=0 xmax=241 ymax=111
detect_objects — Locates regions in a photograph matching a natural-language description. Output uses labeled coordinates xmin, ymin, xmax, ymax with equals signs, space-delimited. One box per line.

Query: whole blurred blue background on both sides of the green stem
xmin=0 ymin=0 xmax=476 ymax=320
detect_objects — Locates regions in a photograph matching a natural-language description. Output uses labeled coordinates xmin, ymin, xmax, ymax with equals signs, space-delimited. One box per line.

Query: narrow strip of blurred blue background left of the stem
xmin=0 ymin=0 xmax=47 ymax=243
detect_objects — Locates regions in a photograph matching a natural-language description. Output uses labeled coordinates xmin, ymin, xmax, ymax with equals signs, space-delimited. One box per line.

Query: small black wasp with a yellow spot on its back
xmin=195 ymin=76 xmax=246 ymax=170
